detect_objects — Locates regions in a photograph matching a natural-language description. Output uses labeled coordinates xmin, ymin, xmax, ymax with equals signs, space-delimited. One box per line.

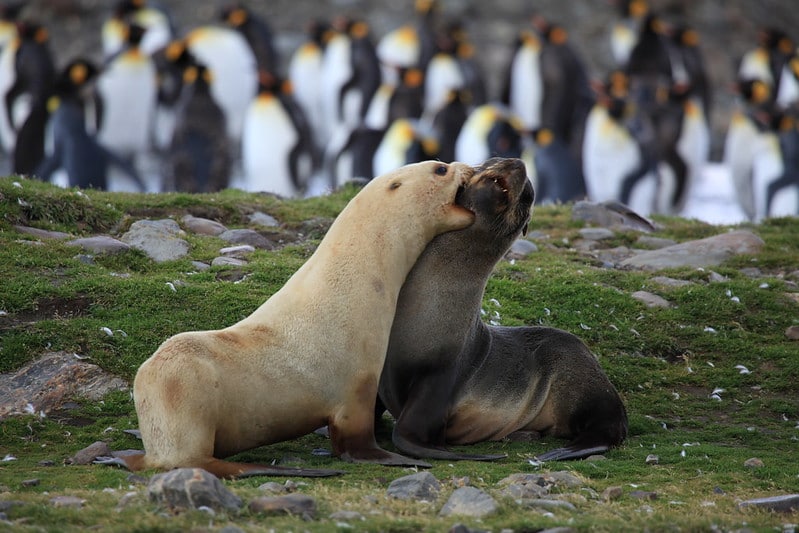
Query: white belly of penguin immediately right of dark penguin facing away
xmin=241 ymin=97 xmax=299 ymax=198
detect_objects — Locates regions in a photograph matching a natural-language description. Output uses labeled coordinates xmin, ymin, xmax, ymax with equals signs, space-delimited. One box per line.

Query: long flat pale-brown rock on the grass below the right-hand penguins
xmin=621 ymin=230 xmax=765 ymax=270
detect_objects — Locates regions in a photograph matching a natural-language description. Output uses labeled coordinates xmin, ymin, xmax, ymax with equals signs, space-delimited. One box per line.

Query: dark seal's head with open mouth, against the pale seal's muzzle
xmin=456 ymin=157 xmax=535 ymax=241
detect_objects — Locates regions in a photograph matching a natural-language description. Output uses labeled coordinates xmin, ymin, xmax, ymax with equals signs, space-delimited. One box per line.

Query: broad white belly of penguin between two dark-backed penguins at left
xmin=97 ymin=52 xmax=157 ymax=155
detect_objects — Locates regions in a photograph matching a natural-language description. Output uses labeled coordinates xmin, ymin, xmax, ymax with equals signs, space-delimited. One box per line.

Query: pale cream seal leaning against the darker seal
xmin=111 ymin=161 xmax=474 ymax=477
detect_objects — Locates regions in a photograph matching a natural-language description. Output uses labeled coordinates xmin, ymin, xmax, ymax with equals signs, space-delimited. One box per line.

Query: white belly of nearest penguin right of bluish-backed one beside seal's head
xmin=583 ymin=106 xmax=654 ymax=204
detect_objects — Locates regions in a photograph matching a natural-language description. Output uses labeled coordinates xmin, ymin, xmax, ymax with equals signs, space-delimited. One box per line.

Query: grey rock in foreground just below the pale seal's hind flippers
xmin=147 ymin=468 xmax=242 ymax=512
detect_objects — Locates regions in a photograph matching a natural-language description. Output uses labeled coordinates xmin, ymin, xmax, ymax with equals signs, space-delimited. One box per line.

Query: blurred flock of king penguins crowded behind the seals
xmin=0 ymin=0 xmax=799 ymax=220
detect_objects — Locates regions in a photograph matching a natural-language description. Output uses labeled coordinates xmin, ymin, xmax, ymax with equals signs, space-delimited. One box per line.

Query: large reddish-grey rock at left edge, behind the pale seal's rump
xmin=0 ymin=352 xmax=128 ymax=419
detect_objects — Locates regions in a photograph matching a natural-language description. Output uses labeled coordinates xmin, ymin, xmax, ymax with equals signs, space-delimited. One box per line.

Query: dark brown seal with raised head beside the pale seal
xmin=378 ymin=158 xmax=627 ymax=460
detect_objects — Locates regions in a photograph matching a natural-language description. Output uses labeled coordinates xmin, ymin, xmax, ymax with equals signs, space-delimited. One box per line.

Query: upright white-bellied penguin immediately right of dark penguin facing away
xmin=241 ymin=71 xmax=315 ymax=198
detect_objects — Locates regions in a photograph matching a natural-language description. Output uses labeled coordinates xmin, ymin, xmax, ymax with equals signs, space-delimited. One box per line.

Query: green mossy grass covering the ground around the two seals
xmin=0 ymin=178 xmax=799 ymax=532
